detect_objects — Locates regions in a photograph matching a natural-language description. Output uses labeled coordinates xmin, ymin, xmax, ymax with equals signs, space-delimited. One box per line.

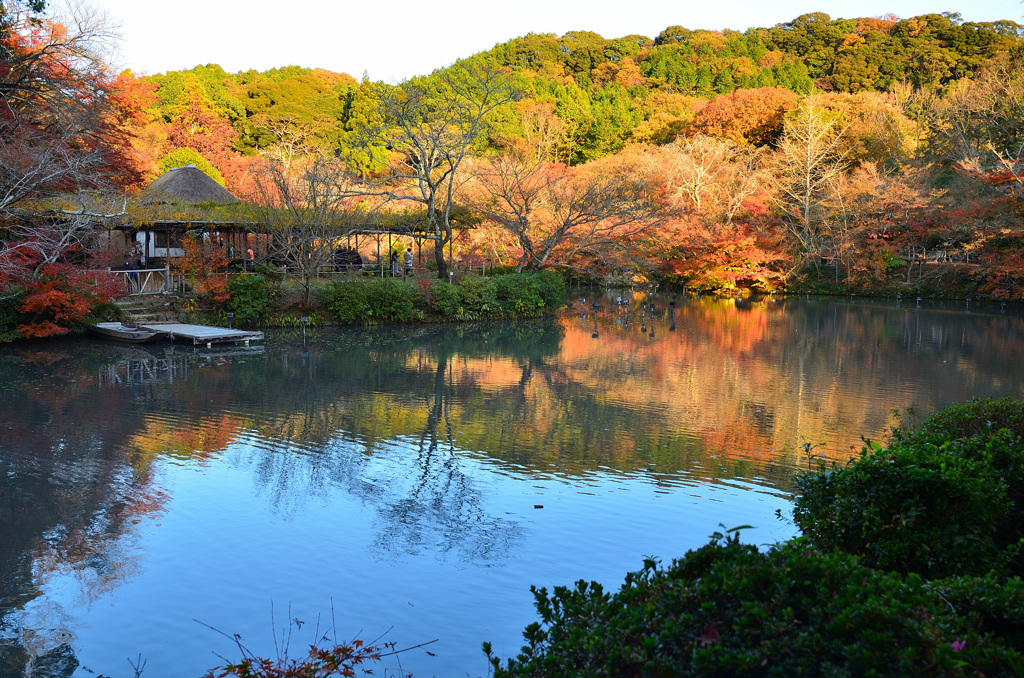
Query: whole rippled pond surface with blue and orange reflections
xmin=0 ymin=292 xmax=1024 ymax=678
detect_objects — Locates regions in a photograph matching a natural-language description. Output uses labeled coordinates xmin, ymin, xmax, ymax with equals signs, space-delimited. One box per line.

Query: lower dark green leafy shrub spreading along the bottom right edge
xmin=484 ymin=538 xmax=1024 ymax=677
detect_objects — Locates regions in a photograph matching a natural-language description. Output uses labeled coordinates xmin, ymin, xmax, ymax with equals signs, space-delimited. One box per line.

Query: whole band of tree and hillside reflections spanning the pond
xmin=0 ymin=303 xmax=1024 ymax=675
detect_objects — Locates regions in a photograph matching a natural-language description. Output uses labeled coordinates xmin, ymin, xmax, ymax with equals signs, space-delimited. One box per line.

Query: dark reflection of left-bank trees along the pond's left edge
xmin=0 ymin=342 xmax=173 ymax=676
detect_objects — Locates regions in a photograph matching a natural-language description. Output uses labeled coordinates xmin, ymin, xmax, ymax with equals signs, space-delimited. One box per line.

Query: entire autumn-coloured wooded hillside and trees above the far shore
xmin=0 ymin=5 xmax=1024 ymax=342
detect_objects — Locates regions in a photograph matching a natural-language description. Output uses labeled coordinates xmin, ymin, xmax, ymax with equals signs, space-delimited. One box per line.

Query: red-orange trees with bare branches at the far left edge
xmin=0 ymin=2 xmax=140 ymax=337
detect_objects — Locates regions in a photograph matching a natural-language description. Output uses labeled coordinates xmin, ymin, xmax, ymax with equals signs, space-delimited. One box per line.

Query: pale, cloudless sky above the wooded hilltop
xmin=83 ymin=0 xmax=1024 ymax=82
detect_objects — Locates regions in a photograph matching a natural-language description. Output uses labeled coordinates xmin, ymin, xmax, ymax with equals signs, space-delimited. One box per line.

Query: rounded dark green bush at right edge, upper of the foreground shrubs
xmin=794 ymin=398 xmax=1024 ymax=578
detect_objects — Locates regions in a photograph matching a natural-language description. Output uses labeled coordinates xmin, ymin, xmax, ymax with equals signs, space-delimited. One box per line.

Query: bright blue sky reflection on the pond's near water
xmin=22 ymin=436 xmax=792 ymax=677
